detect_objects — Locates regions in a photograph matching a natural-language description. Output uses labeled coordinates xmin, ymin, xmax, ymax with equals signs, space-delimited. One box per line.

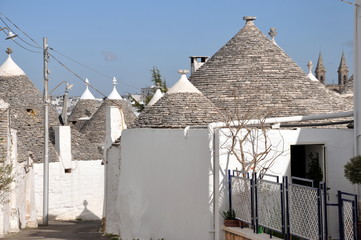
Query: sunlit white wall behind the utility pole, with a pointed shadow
xmin=34 ymin=160 xmax=104 ymax=220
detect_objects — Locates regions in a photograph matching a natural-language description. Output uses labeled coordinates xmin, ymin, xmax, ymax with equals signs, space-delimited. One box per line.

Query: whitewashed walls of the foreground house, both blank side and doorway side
xmin=106 ymin=125 xmax=355 ymax=239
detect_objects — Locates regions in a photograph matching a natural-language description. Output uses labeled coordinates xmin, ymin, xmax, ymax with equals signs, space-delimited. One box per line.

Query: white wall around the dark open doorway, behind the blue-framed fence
xmin=220 ymin=128 xmax=355 ymax=238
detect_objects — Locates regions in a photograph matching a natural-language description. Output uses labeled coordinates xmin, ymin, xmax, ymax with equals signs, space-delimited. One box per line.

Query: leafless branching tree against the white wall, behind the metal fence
xmin=223 ymin=94 xmax=284 ymax=177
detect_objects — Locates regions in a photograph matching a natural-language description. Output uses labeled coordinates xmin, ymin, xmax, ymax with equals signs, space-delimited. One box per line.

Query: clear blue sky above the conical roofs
xmin=0 ymin=0 xmax=354 ymax=97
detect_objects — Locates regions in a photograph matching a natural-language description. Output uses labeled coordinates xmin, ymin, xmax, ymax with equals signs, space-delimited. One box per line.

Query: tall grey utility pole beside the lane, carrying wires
xmin=43 ymin=37 xmax=49 ymax=225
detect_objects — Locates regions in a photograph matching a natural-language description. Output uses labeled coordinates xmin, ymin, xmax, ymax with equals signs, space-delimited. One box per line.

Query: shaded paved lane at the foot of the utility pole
xmin=0 ymin=221 xmax=110 ymax=240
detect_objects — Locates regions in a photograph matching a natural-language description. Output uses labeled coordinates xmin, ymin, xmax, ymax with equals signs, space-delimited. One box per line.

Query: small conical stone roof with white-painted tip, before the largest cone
xmin=133 ymin=74 xmax=224 ymax=128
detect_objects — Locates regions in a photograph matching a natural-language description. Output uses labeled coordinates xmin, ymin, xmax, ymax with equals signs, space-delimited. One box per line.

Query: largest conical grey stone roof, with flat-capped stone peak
xmin=190 ymin=18 xmax=352 ymax=118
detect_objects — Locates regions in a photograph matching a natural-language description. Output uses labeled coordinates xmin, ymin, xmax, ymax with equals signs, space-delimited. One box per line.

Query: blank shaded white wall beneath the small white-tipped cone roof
xmin=112 ymin=129 xmax=212 ymax=240
